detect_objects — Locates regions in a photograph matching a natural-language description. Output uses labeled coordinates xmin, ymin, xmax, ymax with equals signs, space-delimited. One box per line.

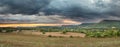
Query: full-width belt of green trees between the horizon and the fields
xmin=0 ymin=26 xmax=120 ymax=37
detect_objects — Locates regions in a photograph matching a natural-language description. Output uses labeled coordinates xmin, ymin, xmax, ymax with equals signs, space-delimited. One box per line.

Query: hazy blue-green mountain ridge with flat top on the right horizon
xmin=80 ymin=20 xmax=120 ymax=28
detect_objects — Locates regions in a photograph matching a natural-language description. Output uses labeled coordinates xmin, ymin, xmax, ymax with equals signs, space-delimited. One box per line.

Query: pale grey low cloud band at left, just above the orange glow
xmin=0 ymin=14 xmax=66 ymax=23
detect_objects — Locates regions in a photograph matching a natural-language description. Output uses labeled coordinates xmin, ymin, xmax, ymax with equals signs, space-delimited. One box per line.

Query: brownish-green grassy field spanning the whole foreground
xmin=0 ymin=33 xmax=120 ymax=47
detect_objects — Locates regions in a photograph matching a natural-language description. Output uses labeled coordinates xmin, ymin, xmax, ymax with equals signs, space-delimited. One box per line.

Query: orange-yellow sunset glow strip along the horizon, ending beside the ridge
xmin=0 ymin=19 xmax=81 ymax=27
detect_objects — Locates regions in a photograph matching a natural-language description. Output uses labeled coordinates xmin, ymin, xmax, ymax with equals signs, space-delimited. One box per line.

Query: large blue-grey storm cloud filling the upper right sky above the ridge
xmin=45 ymin=0 xmax=120 ymax=21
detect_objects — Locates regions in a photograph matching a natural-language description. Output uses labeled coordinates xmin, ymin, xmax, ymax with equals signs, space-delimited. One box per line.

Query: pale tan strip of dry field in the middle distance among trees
xmin=14 ymin=31 xmax=86 ymax=38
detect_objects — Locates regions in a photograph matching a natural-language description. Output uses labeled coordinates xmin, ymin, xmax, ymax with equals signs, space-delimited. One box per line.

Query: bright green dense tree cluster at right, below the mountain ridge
xmin=82 ymin=28 xmax=120 ymax=37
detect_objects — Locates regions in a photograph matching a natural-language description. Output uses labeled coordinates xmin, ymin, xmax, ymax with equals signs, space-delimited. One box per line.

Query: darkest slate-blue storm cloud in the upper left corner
xmin=0 ymin=0 xmax=50 ymax=14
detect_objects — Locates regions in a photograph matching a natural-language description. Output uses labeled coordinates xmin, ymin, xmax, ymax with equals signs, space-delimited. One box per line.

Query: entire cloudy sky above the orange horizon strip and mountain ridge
xmin=0 ymin=0 xmax=120 ymax=24
